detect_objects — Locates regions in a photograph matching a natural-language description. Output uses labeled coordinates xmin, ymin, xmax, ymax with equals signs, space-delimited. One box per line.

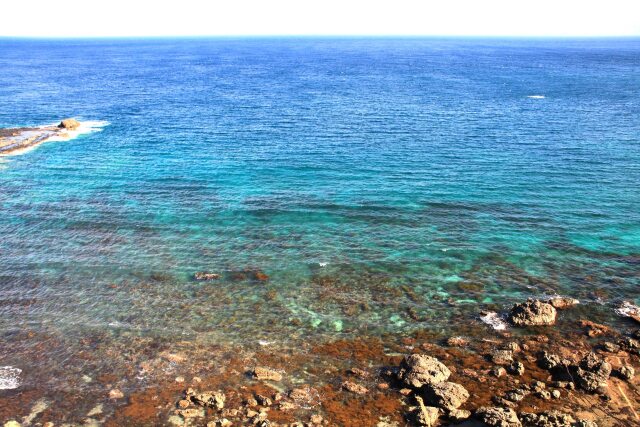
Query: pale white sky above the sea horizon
xmin=0 ymin=0 xmax=640 ymax=37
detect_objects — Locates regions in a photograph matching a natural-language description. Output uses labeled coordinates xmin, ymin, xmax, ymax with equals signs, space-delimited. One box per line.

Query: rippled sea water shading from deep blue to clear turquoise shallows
xmin=0 ymin=38 xmax=640 ymax=374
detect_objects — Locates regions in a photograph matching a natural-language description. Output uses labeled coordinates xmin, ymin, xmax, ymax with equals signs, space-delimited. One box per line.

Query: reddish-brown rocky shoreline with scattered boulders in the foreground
xmin=0 ymin=298 xmax=640 ymax=427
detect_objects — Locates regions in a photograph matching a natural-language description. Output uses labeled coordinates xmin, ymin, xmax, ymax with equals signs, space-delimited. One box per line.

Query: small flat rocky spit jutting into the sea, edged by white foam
xmin=0 ymin=119 xmax=80 ymax=156
